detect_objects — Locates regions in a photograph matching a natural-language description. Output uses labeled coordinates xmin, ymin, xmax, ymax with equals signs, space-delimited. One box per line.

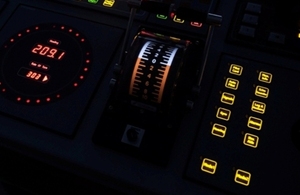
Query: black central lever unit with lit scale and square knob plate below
xmin=94 ymin=31 xmax=200 ymax=164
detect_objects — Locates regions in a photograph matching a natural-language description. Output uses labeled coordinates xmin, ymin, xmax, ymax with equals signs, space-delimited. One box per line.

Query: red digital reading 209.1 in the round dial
xmin=31 ymin=43 xmax=66 ymax=60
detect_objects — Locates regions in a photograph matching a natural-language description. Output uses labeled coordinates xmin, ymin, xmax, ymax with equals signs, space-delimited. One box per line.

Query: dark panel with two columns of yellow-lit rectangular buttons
xmin=186 ymin=56 xmax=300 ymax=195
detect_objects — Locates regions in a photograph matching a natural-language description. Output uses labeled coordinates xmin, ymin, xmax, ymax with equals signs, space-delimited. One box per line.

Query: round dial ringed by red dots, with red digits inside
xmin=0 ymin=24 xmax=91 ymax=105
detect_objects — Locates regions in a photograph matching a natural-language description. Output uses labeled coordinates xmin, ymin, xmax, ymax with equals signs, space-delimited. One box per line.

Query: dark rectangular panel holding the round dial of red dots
xmin=0 ymin=6 xmax=122 ymax=136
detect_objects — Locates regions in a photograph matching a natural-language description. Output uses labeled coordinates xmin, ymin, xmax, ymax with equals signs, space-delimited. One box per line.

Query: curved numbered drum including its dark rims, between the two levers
xmin=118 ymin=31 xmax=191 ymax=112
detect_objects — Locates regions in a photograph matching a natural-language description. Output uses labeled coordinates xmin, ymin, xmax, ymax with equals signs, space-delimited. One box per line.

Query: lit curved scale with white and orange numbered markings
xmin=129 ymin=41 xmax=178 ymax=103
